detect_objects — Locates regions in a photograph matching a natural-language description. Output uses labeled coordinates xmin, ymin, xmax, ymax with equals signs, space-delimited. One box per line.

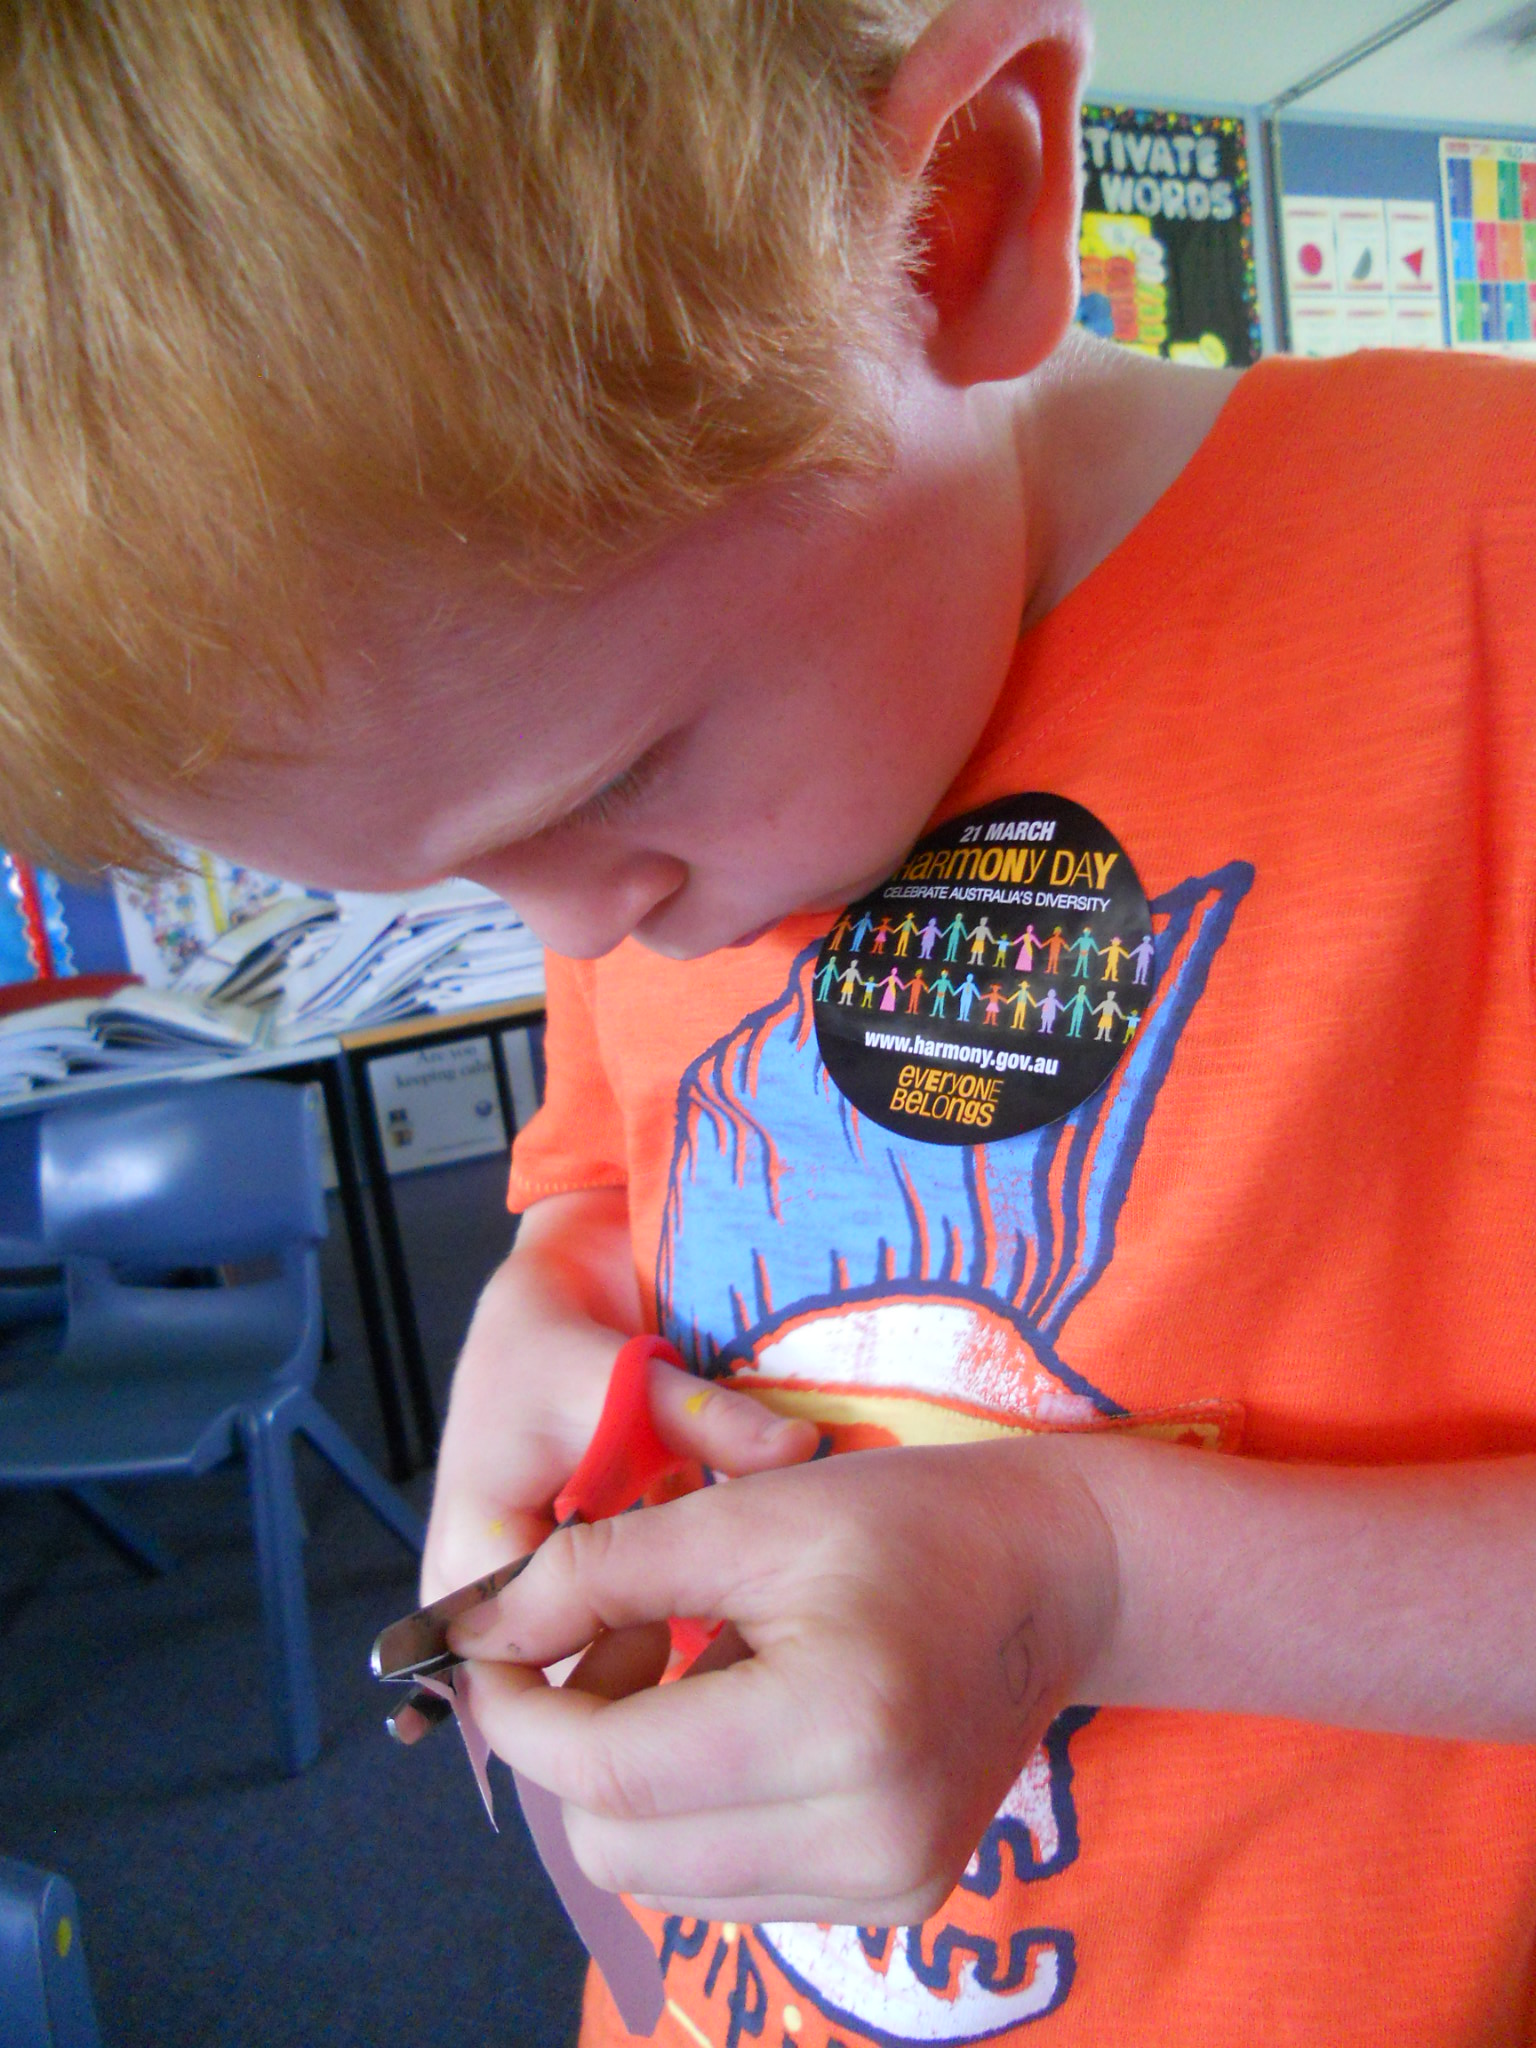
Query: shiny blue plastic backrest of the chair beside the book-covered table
xmin=37 ymin=1079 xmax=326 ymax=1270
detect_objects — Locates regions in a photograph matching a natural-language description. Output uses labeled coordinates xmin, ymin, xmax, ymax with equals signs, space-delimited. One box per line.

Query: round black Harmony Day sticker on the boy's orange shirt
xmin=813 ymin=795 xmax=1155 ymax=1145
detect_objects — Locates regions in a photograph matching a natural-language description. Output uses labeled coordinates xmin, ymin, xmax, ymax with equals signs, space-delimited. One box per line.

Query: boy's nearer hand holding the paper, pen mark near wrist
xmin=453 ymin=1442 xmax=1116 ymax=1925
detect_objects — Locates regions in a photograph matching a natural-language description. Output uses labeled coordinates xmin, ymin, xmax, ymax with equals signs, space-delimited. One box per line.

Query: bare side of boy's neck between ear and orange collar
xmin=1014 ymin=330 xmax=1239 ymax=627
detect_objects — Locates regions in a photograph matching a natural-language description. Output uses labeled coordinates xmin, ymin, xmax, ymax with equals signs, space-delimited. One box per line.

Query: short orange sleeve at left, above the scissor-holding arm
xmin=506 ymin=954 xmax=629 ymax=1214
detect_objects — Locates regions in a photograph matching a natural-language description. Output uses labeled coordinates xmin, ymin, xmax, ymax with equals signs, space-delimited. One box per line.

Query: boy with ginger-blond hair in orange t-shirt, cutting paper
xmin=0 ymin=0 xmax=1536 ymax=2048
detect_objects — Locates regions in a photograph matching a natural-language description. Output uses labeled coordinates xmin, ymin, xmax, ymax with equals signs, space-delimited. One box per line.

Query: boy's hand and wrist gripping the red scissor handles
xmin=422 ymin=1192 xmax=817 ymax=1599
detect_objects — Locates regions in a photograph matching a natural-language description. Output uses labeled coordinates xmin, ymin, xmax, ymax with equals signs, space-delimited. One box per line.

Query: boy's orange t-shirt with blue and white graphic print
xmin=512 ymin=356 xmax=1536 ymax=2048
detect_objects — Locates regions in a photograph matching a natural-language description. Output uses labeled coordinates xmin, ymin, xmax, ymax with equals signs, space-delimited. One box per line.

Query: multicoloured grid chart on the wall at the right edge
xmin=1440 ymin=135 xmax=1536 ymax=356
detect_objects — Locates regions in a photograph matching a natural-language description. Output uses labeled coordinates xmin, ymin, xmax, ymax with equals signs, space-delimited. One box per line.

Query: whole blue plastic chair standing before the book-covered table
xmin=0 ymin=1079 xmax=424 ymax=1772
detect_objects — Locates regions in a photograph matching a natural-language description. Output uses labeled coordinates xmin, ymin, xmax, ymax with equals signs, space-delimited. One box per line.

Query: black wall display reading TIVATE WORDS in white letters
xmin=1077 ymin=106 xmax=1260 ymax=369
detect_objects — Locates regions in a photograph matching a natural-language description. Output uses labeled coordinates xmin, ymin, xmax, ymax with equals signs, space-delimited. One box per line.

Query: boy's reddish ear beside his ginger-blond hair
xmin=881 ymin=0 xmax=1090 ymax=385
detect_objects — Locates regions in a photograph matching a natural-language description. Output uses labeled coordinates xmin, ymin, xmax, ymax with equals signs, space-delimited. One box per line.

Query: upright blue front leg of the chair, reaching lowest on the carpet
xmin=240 ymin=1411 xmax=319 ymax=1776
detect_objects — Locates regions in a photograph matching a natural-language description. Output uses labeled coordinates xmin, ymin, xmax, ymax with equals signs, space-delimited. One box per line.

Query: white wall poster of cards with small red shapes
xmin=1282 ymin=193 xmax=1446 ymax=356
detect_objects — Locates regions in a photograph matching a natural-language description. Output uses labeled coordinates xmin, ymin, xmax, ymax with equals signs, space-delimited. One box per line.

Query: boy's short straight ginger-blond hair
xmin=0 ymin=0 xmax=938 ymax=866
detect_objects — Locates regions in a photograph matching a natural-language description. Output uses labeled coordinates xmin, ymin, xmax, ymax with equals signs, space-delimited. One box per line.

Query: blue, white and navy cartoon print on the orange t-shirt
xmin=647 ymin=862 xmax=1253 ymax=2048
